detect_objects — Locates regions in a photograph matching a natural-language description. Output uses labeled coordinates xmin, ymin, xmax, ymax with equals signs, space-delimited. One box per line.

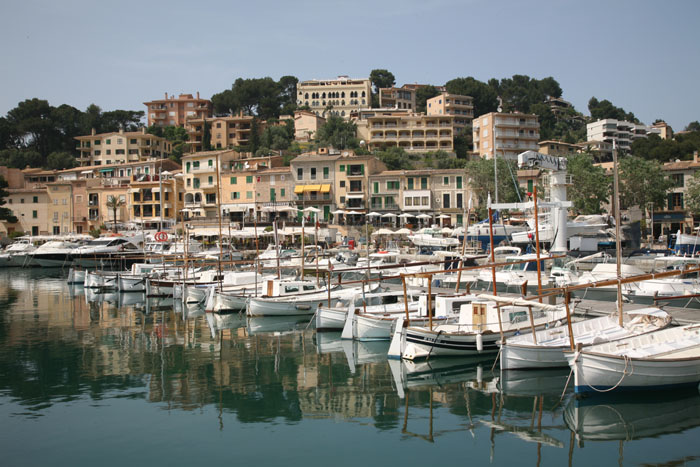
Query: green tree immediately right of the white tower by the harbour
xmin=567 ymin=153 xmax=611 ymax=214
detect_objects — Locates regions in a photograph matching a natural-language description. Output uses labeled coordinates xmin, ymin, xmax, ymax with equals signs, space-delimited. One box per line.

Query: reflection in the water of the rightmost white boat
xmin=564 ymin=388 xmax=700 ymax=447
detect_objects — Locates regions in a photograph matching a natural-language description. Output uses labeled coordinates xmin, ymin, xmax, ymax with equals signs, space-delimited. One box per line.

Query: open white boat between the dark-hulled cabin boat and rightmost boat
xmin=500 ymin=308 xmax=671 ymax=370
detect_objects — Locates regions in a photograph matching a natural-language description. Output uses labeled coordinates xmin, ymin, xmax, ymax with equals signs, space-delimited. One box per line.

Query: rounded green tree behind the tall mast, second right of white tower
xmin=618 ymin=156 xmax=672 ymax=225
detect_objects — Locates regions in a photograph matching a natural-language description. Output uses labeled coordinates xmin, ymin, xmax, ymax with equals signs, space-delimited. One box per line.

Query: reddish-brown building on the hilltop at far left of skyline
xmin=143 ymin=92 xmax=213 ymax=126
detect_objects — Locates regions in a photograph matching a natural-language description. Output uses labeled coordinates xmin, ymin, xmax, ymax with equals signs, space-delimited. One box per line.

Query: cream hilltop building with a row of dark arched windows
xmin=297 ymin=76 xmax=372 ymax=118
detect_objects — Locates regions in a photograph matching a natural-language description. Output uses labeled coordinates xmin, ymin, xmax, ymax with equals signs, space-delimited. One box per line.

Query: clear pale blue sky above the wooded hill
xmin=0 ymin=0 xmax=700 ymax=130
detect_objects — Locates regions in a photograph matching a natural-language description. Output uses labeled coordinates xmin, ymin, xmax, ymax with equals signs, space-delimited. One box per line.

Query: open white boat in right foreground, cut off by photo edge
xmin=565 ymin=324 xmax=700 ymax=393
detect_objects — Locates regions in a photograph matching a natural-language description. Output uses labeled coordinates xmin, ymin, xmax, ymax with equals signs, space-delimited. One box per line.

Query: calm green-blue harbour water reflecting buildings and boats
xmin=0 ymin=269 xmax=700 ymax=466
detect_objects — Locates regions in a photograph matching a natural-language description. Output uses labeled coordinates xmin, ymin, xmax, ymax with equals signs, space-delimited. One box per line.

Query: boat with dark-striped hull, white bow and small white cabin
xmin=389 ymin=295 xmax=566 ymax=360
